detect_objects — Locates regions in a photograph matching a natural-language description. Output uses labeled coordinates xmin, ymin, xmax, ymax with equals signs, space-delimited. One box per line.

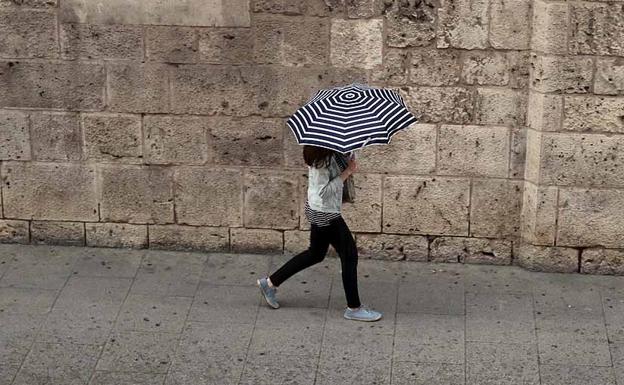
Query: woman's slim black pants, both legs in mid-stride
xmin=269 ymin=217 xmax=360 ymax=308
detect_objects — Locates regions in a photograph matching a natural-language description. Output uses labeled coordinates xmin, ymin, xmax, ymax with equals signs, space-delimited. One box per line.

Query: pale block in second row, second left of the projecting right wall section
xmin=461 ymin=51 xmax=509 ymax=86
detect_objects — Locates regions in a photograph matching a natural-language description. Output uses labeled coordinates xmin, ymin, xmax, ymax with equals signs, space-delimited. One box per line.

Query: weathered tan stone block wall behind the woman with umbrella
xmin=0 ymin=0 xmax=624 ymax=274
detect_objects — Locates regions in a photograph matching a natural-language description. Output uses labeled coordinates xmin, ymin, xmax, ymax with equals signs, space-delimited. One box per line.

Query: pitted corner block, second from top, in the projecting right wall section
xmin=531 ymin=55 xmax=593 ymax=94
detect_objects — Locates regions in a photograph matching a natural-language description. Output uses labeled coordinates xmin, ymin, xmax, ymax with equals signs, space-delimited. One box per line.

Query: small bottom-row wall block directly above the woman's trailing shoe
xmin=230 ymin=228 xmax=284 ymax=254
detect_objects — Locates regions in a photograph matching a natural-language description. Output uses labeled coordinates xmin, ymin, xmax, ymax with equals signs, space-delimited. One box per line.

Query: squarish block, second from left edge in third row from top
xmin=107 ymin=62 xmax=169 ymax=113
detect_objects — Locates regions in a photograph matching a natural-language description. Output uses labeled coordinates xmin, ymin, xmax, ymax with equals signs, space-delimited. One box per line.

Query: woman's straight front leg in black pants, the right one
xmin=330 ymin=217 xmax=361 ymax=309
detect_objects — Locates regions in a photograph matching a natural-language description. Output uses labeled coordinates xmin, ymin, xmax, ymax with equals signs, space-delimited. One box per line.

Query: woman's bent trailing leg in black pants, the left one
xmin=269 ymin=224 xmax=329 ymax=287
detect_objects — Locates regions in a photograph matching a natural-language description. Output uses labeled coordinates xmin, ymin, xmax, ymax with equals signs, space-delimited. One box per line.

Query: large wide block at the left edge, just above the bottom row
xmin=1 ymin=162 xmax=98 ymax=221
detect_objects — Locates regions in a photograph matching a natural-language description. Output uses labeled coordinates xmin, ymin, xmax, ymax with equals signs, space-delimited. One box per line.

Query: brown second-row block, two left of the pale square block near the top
xmin=199 ymin=28 xmax=254 ymax=64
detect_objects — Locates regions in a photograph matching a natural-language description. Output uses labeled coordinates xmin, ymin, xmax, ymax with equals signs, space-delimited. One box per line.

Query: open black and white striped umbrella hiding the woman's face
xmin=286 ymin=83 xmax=418 ymax=154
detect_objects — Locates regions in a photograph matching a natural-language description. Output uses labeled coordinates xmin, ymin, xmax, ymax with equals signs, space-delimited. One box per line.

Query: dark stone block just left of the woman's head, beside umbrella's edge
xmin=209 ymin=117 xmax=286 ymax=167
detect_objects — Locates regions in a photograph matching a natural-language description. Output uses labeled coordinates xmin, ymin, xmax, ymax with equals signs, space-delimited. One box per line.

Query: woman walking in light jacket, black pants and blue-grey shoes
xmin=256 ymin=145 xmax=382 ymax=321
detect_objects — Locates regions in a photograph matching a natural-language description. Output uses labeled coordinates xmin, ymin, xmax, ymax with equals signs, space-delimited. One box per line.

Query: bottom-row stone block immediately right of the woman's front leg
xmin=356 ymin=234 xmax=429 ymax=262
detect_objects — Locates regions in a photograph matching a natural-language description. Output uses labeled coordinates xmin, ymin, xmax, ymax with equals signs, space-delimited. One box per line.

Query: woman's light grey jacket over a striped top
xmin=308 ymin=156 xmax=344 ymax=213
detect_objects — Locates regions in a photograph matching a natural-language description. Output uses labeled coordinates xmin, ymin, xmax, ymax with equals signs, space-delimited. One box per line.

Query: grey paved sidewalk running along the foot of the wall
xmin=0 ymin=244 xmax=624 ymax=385
